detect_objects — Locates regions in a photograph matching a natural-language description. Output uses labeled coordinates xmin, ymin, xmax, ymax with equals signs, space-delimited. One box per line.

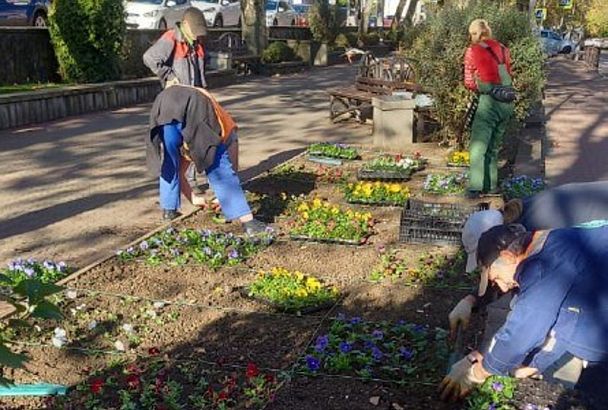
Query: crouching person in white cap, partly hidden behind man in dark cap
xmin=448 ymin=181 xmax=608 ymax=336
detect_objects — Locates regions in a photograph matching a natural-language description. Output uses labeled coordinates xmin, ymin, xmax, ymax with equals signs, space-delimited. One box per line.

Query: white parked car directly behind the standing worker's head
xmin=125 ymin=0 xmax=191 ymax=30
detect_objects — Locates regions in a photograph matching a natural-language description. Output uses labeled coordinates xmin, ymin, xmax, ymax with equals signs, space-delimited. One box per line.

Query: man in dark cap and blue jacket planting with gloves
xmin=440 ymin=224 xmax=608 ymax=400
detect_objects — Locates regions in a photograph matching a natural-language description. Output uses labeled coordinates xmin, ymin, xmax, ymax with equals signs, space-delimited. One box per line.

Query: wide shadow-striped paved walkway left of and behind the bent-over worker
xmin=0 ymin=66 xmax=370 ymax=267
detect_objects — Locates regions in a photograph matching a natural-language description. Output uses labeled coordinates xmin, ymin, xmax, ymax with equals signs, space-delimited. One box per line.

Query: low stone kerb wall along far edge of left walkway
xmin=0 ymin=71 xmax=234 ymax=129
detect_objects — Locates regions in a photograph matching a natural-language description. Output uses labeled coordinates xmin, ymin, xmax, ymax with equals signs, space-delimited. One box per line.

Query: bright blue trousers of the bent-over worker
xmin=159 ymin=122 xmax=251 ymax=220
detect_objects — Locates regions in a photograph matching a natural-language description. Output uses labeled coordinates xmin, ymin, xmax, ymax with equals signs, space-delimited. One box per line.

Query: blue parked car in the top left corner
xmin=0 ymin=0 xmax=51 ymax=27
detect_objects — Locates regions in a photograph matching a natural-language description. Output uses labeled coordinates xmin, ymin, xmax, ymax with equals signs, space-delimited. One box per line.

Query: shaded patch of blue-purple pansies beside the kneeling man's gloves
xmin=300 ymin=316 xmax=448 ymax=383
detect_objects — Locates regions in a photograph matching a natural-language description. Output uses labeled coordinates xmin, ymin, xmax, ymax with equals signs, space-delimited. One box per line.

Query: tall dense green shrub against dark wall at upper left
xmin=49 ymin=0 xmax=126 ymax=82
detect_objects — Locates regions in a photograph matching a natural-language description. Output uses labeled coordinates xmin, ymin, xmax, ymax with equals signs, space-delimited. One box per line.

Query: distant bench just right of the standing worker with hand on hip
xmin=207 ymin=33 xmax=259 ymax=74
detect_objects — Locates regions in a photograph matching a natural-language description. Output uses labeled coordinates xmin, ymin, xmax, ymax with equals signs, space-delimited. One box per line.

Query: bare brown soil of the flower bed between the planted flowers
xmin=0 ymin=145 xmax=584 ymax=410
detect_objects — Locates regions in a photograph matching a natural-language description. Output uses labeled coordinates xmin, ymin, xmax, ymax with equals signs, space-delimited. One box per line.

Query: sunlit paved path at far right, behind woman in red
xmin=545 ymin=58 xmax=608 ymax=185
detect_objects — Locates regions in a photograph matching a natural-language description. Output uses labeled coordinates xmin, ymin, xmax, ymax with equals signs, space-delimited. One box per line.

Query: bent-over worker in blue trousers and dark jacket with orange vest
xmin=146 ymin=85 xmax=266 ymax=234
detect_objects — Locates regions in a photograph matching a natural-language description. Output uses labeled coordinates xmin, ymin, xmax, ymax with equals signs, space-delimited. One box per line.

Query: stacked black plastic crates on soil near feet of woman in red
xmin=399 ymin=199 xmax=489 ymax=245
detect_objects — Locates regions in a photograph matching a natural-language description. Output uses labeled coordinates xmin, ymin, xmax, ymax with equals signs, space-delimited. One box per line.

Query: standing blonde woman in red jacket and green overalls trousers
xmin=464 ymin=19 xmax=514 ymax=197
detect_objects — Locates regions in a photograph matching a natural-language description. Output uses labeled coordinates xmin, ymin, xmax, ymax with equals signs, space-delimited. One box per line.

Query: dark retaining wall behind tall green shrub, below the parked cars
xmin=0 ymin=27 xmax=312 ymax=84
